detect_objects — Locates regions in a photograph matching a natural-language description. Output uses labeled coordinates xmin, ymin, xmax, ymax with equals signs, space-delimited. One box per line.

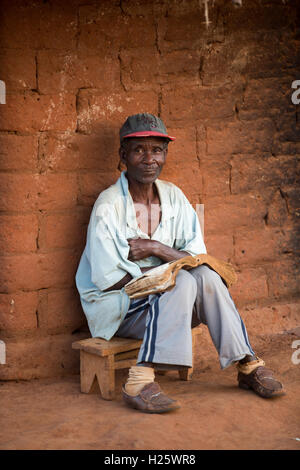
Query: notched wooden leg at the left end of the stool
xmin=80 ymin=350 xmax=115 ymax=400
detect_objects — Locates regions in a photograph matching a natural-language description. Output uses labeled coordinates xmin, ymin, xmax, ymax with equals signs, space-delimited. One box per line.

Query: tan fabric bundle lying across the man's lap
xmin=124 ymin=254 xmax=237 ymax=299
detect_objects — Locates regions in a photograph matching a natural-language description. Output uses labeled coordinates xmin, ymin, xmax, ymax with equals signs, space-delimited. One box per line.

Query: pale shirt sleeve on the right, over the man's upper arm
xmin=174 ymin=191 xmax=207 ymax=256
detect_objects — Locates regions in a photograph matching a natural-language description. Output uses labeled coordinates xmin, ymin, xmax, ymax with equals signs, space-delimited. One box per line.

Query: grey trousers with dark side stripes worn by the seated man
xmin=116 ymin=265 xmax=254 ymax=369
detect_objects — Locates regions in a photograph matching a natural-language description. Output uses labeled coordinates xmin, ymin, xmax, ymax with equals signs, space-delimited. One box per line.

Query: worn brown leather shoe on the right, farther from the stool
xmin=238 ymin=366 xmax=285 ymax=398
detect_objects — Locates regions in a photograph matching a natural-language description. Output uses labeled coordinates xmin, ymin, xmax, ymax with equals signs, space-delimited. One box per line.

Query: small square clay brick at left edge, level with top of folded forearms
xmin=0 ymin=214 xmax=38 ymax=254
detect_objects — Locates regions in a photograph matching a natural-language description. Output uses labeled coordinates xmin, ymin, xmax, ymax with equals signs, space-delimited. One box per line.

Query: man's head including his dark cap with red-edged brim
xmin=119 ymin=113 xmax=175 ymax=183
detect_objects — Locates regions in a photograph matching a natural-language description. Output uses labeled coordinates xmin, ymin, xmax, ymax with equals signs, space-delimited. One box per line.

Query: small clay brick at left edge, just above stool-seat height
xmin=0 ymin=292 xmax=38 ymax=334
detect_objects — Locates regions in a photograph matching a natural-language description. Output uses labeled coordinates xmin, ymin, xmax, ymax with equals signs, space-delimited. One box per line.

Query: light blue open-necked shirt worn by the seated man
xmin=76 ymin=171 xmax=206 ymax=340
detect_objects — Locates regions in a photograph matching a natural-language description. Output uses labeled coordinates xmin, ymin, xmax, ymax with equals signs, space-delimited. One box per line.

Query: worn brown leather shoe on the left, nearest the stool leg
xmin=122 ymin=382 xmax=180 ymax=413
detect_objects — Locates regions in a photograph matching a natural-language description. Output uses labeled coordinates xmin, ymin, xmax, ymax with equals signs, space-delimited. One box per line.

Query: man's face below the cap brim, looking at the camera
xmin=120 ymin=137 xmax=168 ymax=184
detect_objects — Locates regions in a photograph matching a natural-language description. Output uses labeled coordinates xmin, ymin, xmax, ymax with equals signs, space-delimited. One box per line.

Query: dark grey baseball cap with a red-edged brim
xmin=120 ymin=113 xmax=175 ymax=141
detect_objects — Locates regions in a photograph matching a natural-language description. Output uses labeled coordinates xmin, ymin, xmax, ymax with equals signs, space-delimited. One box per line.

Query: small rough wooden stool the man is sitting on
xmin=72 ymin=327 xmax=201 ymax=400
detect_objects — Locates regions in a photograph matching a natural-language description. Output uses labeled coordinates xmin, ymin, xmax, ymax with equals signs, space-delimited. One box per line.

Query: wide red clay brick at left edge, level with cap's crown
xmin=0 ymin=91 xmax=77 ymax=132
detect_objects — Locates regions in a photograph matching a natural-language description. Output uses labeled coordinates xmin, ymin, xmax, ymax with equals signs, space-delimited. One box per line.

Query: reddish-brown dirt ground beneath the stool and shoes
xmin=0 ymin=334 xmax=300 ymax=450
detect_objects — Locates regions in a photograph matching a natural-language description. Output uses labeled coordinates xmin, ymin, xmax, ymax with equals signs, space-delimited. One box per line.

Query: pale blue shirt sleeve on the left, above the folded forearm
xmin=86 ymin=204 xmax=142 ymax=291
